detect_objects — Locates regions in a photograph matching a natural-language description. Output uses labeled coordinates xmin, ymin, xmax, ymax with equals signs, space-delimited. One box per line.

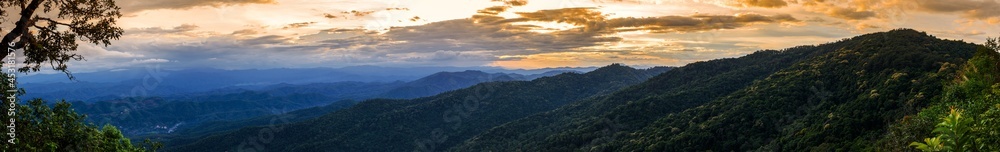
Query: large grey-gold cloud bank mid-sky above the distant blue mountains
xmin=272 ymin=8 xmax=802 ymax=67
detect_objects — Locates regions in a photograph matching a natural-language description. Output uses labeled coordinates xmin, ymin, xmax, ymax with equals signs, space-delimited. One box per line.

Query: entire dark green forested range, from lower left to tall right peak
xmin=165 ymin=29 xmax=1000 ymax=151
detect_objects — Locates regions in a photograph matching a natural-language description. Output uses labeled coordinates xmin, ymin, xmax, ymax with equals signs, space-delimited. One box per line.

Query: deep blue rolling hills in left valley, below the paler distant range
xmin=73 ymin=71 xmax=558 ymax=135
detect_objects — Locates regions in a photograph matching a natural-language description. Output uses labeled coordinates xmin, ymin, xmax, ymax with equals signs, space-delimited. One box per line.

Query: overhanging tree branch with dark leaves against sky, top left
xmin=0 ymin=0 xmax=123 ymax=76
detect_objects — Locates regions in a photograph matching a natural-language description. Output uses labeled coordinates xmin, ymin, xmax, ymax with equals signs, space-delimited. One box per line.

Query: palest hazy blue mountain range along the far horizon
xmin=18 ymin=66 xmax=592 ymax=102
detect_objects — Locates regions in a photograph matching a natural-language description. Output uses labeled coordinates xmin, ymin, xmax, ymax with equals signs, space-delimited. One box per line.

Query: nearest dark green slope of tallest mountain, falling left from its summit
xmin=608 ymin=30 xmax=976 ymax=151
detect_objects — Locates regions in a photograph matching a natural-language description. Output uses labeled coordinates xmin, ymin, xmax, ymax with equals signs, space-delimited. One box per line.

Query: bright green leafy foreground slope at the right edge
xmin=888 ymin=44 xmax=1000 ymax=151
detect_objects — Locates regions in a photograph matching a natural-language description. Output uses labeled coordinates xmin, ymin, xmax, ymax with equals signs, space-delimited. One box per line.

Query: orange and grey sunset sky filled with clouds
xmin=3 ymin=0 xmax=1000 ymax=72
